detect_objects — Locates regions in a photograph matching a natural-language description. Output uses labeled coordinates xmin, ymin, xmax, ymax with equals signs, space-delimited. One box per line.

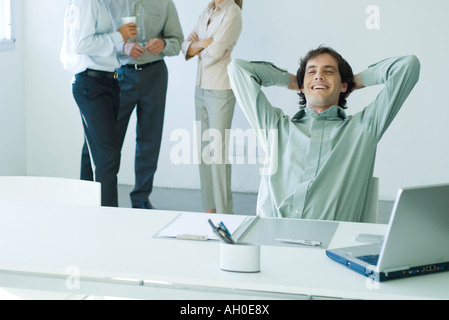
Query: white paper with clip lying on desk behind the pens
xmin=154 ymin=212 xmax=256 ymax=241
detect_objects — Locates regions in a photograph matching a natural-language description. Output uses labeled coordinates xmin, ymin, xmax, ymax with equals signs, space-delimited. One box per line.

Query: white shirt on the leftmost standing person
xmin=61 ymin=0 xmax=123 ymax=74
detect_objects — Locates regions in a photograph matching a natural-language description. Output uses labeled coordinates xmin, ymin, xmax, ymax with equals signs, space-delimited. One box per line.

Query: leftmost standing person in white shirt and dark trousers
xmin=61 ymin=0 xmax=137 ymax=207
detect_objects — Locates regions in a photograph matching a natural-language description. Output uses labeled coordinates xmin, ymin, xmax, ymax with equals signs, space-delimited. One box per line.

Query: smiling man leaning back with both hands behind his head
xmin=228 ymin=47 xmax=420 ymax=221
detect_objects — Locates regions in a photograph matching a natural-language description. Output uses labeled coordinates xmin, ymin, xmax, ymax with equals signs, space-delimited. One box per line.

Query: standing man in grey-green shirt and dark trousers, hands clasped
xmin=82 ymin=0 xmax=184 ymax=209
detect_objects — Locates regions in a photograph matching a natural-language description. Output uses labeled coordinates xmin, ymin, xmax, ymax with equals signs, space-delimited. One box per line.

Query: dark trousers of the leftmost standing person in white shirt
xmin=72 ymin=73 xmax=120 ymax=207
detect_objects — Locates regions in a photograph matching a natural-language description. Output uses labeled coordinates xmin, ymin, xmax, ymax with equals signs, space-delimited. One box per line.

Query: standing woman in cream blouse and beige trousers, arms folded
xmin=182 ymin=0 xmax=243 ymax=214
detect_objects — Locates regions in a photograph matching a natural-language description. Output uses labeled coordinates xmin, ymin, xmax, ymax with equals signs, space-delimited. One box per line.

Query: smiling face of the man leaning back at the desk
xmin=301 ymin=53 xmax=348 ymax=113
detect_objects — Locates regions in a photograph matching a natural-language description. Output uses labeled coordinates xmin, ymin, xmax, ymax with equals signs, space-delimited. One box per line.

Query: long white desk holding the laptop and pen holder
xmin=0 ymin=201 xmax=449 ymax=299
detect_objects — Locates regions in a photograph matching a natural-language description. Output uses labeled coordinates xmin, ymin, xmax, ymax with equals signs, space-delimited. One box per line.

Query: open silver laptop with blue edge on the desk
xmin=326 ymin=184 xmax=449 ymax=282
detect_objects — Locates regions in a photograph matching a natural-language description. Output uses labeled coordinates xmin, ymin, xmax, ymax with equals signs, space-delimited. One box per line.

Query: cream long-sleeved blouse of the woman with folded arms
xmin=182 ymin=0 xmax=242 ymax=90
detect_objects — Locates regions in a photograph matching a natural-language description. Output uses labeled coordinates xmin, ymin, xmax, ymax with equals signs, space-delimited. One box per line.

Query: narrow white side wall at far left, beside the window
xmin=0 ymin=0 xmax=26 ymax=175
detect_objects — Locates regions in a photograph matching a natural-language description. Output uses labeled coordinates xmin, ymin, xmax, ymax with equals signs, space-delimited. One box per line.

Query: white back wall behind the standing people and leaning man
xmin=14 ymin=0 xmax=449 ymax=200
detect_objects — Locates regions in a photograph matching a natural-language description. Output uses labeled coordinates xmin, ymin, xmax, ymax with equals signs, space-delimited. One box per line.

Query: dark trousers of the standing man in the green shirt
xmin=81 ymin=60 xmax=168 ymax=206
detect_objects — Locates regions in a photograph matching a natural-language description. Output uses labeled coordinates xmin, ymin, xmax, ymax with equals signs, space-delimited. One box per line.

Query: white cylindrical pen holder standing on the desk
xmin=220 ymin=243 xmax=260 ymax=272
